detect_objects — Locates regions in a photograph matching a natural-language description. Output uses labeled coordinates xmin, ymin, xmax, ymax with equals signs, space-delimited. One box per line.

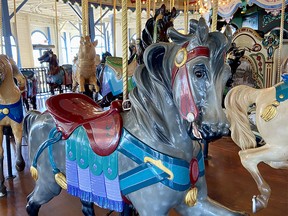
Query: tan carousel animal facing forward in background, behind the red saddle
xmin=72 ymin=36 xmax=100 ymax=93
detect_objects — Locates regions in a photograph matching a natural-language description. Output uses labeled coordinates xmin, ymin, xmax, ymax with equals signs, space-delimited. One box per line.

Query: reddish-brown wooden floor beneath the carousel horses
xmin=0 ymin=93 xmax=288 ymax=216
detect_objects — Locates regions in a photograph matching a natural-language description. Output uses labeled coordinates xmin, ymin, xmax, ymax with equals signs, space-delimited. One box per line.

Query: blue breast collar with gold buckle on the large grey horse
xmin=117 ymin=129 xmax=205 ymax=195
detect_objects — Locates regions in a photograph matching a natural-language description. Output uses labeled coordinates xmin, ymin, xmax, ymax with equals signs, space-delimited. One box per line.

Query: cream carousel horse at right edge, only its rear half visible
xmin=225 ymin=74 xmax=288 ymax=213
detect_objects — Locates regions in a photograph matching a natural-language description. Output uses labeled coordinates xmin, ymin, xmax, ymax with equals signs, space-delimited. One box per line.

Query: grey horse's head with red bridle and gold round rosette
xmin=169 ymin=18 xmax=232 ymax=140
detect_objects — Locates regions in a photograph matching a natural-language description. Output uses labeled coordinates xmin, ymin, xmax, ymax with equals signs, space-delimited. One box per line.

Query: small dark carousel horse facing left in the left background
xmin=38 ymin=50 xmax=65 ymax=95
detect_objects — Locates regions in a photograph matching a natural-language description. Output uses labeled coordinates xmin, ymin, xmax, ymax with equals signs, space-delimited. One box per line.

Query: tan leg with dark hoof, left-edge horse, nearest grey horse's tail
xmin=11 ymin=122 xmax=25 ymax=171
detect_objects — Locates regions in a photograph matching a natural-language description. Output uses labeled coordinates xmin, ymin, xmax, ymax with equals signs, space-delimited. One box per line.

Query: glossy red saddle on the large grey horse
xmin=46 ymin=93 xmax=123 ymax=156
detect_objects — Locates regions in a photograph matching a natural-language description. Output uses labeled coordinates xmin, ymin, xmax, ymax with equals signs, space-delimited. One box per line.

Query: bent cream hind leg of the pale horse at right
xmin=239 ymin=144 xmax=287 ymax=213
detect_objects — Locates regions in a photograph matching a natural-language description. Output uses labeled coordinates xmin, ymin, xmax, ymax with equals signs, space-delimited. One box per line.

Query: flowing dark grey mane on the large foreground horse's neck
xmin=129 ymin=43 xmax=175 ymax=145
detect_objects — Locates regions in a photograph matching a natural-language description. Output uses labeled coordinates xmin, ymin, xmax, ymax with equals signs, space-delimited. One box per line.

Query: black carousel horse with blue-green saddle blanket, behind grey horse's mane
xmin=99 ymin=4 xmax=177 ymax=107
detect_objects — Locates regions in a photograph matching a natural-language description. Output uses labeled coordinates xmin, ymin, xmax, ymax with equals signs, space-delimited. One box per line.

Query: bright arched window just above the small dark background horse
xmin=31 ymin=31 xmax=48 ymax=67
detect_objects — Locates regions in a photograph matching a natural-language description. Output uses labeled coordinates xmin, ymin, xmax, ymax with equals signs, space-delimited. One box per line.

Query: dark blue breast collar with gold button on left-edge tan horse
xmin=0 ymin=98 xmax=23 ymax=124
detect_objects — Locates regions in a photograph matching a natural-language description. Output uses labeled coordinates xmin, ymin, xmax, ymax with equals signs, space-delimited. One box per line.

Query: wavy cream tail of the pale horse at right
xmin=225 ymin=85 xmax=259 ymax=150
